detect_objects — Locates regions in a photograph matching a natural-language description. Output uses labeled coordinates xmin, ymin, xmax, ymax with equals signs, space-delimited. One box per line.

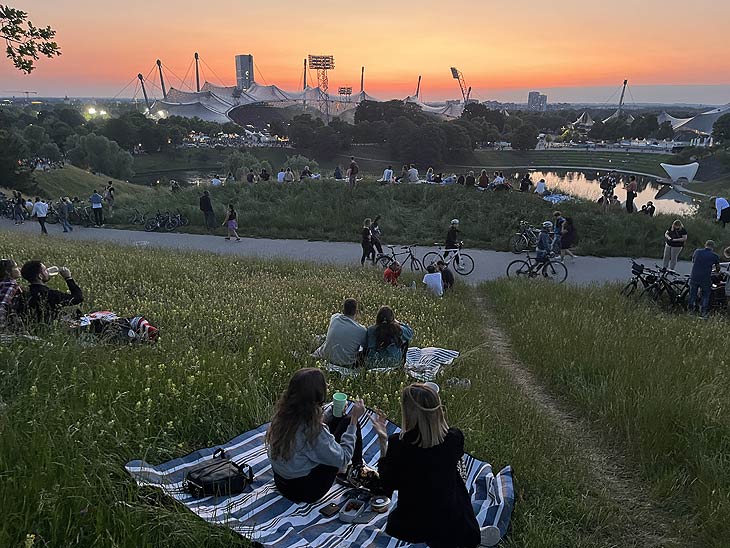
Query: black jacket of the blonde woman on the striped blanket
xmin=378 ymin=428 xmax=480 ymax=548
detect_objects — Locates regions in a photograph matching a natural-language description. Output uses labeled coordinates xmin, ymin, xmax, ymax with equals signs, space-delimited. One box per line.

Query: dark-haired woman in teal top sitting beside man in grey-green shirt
xmin=365 ymin=306 xmax=413 ymax=367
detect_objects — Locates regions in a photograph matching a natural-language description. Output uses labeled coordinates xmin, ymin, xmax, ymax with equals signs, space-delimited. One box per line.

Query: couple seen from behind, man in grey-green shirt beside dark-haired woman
xmin=312 ymin=299 xmax=413 ymax=367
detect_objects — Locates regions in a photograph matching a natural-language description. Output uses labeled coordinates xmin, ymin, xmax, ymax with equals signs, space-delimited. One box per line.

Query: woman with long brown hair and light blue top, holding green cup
xmin=266 ymin=368 xmax=365 ymax=503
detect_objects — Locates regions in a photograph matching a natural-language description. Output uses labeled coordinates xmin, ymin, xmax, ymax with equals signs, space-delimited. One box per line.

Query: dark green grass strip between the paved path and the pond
xmin=109 ymin=181 xmax=725 ymax=257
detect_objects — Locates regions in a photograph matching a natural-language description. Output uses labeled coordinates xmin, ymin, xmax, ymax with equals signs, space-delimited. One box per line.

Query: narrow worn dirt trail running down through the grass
xmin=476 ymin=295 xmax=688 ymax=548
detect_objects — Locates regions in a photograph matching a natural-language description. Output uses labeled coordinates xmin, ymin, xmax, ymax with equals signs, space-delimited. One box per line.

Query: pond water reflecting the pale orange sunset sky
xmin=505 ymin=170 xmax=698 ymax=215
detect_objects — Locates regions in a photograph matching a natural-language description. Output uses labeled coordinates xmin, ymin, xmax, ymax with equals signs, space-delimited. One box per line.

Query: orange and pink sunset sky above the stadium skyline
xmin=0 ymin=0 xmax=730 ymax=104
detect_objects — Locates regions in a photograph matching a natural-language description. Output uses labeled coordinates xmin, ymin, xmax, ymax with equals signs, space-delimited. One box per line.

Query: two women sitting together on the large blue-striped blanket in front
xmin=266 ymin=368 xmax=499 ymax=548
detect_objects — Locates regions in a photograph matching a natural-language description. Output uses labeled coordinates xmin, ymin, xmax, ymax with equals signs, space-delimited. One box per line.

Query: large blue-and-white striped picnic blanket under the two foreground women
xmin=125 ymin=404 xmax=514 ymax=548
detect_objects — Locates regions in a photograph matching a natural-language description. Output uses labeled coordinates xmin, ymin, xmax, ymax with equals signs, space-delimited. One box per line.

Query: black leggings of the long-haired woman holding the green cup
xmin=274 ymin=415 xmax=362 ymax=502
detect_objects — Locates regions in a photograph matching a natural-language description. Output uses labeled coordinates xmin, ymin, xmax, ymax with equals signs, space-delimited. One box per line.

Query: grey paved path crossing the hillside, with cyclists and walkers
xmin=0 ymin=219 xmax=690 ymax=285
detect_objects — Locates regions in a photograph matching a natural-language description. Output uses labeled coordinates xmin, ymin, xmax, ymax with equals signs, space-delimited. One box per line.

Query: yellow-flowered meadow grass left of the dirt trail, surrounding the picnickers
xmin=0 ymin=233 xmax=692 ymax=548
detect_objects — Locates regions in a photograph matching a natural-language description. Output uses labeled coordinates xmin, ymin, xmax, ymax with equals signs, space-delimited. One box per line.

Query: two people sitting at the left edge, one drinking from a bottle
xmin=0 ymin=259 xmax=84 ymax=330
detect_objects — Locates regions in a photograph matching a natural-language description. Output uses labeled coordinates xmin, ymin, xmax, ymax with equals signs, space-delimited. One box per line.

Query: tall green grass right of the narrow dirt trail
xmin=483 ymin=282 xmax=730 ymax=548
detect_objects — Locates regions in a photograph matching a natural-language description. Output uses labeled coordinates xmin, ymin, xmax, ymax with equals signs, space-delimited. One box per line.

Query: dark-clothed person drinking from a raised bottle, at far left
xmin=20 ymin=261 xmax=84 ymax=323
